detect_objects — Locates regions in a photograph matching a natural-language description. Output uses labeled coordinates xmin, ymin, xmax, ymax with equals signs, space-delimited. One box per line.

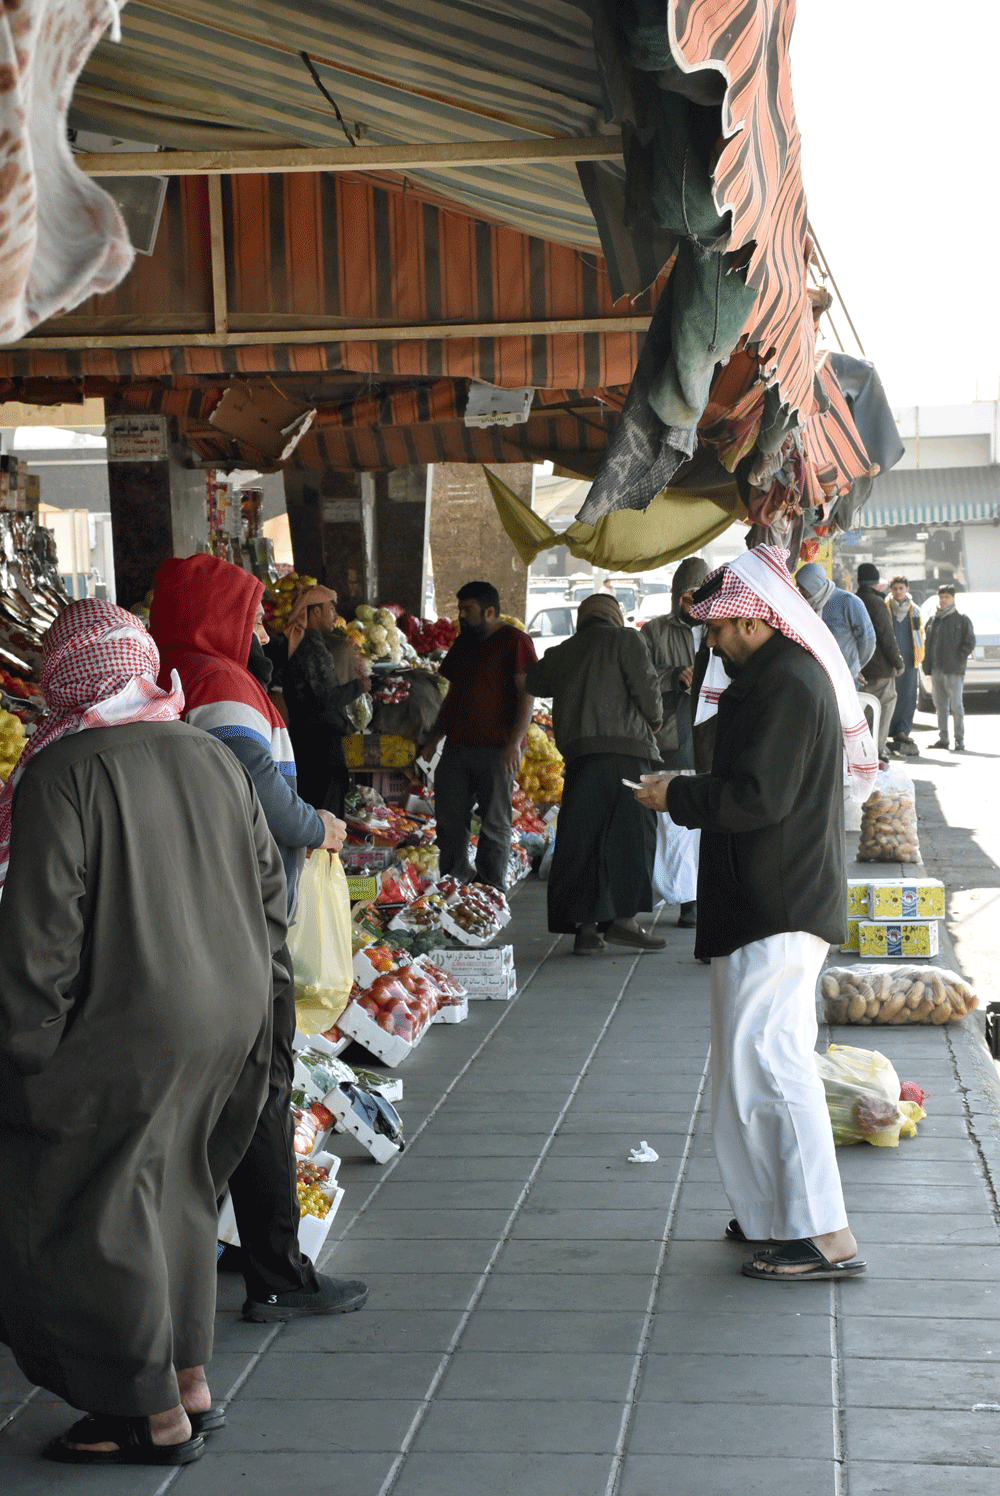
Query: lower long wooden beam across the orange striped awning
xmin=13 ymin=317 xmax=650 ymax=355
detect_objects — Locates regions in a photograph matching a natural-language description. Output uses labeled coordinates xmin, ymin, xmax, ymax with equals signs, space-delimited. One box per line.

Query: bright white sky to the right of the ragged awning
xmin=792 ymin=0 xmax=1000 ymax=407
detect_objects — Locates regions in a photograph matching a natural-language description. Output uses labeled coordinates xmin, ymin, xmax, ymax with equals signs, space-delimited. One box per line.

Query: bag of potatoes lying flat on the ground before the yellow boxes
xmin=819 ymin=966 xmax=979 ymax=1025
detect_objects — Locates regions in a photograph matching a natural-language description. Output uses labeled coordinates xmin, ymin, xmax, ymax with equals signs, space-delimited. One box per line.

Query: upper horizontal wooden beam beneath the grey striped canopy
xmin=73 ymin=135 xmax=621 ymax=177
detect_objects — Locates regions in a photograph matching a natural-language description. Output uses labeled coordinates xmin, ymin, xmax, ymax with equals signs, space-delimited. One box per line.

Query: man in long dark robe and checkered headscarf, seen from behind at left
xmin=0 ymin=598 xmax=286 ymax=1465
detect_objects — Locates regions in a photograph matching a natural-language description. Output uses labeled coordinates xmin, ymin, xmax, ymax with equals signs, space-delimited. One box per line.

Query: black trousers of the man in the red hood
xmin=229 ymin=945 xmax=319 ymax=1303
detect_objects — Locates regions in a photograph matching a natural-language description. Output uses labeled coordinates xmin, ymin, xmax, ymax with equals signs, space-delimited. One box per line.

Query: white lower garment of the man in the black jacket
xmin=711 ymin=931 xmax=847 ymax=1242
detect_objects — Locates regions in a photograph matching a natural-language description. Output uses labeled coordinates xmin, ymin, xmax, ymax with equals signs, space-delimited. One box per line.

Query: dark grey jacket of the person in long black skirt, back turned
xmin=525 ymin=618 xmax=660 ymax=760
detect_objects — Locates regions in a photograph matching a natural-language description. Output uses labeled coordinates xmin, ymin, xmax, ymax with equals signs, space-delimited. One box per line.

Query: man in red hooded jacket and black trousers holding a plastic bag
xmin=150 ymin=555 xmax=368 ymax=1322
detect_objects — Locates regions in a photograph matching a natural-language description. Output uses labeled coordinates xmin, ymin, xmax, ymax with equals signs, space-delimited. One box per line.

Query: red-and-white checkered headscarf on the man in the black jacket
xmin=689 ymin=546 xmax=879 ymax=802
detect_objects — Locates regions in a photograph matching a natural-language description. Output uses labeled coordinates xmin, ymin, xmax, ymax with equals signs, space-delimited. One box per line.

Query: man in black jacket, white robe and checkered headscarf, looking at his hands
xmin=636 ymin=546 xmax=877 ymax=1281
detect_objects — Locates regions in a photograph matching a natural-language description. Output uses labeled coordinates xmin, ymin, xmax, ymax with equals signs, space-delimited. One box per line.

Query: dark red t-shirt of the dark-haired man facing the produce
xmin=437 ymin=624 xmax=537 ymax=748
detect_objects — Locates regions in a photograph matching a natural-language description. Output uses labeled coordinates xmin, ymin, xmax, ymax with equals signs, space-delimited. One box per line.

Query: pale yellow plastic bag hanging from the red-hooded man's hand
xmin=289 ymin=850 xmax=355 ymax=1034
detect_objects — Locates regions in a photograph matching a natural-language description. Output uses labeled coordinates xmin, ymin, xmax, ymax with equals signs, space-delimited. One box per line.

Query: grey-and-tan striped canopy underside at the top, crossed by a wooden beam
xmin=70 ymin=0 xmax=600 ymax=248
